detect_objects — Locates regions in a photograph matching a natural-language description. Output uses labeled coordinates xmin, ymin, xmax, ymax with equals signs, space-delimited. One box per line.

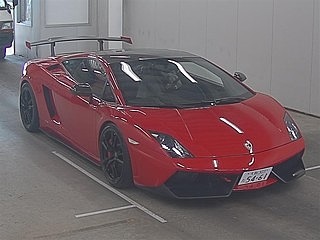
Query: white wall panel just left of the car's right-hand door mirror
xmin=205 ymin=0 xmax=238 ymax=71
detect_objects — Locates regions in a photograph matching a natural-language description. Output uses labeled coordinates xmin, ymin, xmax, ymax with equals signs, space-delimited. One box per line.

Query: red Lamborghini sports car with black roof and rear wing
xmin=20 ymin=37 xmax=305 ymax=198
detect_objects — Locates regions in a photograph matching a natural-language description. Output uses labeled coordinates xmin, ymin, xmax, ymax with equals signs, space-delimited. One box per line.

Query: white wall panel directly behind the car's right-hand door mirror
xmin=237 ymin=0 xmax=273 ymax=93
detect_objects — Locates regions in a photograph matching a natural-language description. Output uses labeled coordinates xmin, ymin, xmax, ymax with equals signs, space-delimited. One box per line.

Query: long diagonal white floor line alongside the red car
xmin=52 ymin=151 xmax=167 ymax=223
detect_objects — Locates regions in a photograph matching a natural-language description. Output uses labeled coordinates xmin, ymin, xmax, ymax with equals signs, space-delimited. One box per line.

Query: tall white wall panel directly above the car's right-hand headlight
xmin=271 ymin=0 xmax=313 ymax=110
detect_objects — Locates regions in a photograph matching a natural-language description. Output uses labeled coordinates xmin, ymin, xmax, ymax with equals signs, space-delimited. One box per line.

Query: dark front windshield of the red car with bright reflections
xmin=111 ymin=57 xmax=253 ymax=108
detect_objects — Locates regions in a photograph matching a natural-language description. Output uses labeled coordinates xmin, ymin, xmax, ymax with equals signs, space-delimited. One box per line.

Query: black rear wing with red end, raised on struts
xmin=26 ymin=36 xmax=132 ymax=57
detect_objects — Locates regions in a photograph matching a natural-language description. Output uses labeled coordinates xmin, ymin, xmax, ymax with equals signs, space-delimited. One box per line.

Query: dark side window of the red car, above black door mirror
xmin=63 ymin=58 xmax=113 ymax=100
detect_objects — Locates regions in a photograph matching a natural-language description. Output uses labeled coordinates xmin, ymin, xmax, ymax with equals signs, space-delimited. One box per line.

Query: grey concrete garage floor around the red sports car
xmin=0 ymin=56 xmax=320 ymax=240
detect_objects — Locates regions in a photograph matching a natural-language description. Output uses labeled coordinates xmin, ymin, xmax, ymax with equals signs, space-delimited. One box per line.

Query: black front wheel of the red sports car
xmin=100 ymin=124 xmax=133 ymax=188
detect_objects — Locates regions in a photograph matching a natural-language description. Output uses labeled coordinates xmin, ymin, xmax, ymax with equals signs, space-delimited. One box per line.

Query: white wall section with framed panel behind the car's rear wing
xmin=16 ymin=0 xmax=101 ymax=58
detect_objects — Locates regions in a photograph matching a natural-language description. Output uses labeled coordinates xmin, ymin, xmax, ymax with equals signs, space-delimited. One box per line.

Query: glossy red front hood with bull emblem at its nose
xmin=125 ymin=94 xmax=290 ymax=157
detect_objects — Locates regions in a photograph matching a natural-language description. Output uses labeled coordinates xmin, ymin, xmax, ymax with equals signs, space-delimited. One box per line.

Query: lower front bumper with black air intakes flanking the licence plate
xmin=152 ymin=151 xmax=305 ymax=199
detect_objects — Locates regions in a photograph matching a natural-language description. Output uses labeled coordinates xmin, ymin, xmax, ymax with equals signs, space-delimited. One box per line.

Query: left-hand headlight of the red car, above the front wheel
xmin=151 ymin=132 xmax=193 ymax=158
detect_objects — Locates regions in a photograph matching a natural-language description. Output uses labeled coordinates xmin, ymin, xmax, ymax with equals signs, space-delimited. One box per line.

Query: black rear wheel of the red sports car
xmin=20 ymin=83 xmax=39 ymax=132
